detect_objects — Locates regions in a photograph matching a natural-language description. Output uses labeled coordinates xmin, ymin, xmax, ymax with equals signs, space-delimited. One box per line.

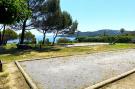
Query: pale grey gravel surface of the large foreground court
xmin=20 ymin=49 xmax=135 ymax=89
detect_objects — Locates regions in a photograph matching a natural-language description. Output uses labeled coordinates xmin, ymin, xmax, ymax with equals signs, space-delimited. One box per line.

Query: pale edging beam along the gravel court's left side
xmin=15 ymin=61 xmax=38 ymax=89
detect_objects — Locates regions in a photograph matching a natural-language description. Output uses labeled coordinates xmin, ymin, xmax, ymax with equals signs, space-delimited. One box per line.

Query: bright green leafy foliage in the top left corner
xmin=0 ymin=0 xmax=27 ymax=24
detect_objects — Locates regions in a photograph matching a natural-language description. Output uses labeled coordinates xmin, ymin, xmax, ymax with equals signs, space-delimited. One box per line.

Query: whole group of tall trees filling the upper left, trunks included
xmin=0 ymin=0 xmax=78 ymax=45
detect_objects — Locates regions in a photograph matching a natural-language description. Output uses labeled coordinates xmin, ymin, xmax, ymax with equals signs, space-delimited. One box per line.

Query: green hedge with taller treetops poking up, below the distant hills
xmin=76 ymin=28 xmax=135 ymax=44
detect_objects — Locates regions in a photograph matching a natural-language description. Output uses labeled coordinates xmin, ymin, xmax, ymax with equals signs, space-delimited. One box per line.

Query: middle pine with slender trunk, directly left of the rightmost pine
xmin=34 ymin=0 xmax=59 ymax=44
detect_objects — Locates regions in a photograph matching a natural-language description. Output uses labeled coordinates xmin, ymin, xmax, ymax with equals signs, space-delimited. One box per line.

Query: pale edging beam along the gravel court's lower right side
xmin=85 ymin=69 xmax=135 ymax=89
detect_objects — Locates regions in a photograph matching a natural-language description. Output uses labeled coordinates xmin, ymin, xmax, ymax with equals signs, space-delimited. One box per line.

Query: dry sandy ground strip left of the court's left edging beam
xmin=6 ymin=63 xmax=30 ymax=89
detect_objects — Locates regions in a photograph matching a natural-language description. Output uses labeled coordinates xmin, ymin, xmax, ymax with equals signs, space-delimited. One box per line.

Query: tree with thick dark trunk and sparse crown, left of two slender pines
xmin=14 ymin=0 xmax=46 ymax=44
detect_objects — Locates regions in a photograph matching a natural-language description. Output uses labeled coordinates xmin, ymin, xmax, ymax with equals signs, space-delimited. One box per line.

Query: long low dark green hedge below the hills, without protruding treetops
xmin=77 ymin=36 xmax=134 ymax=43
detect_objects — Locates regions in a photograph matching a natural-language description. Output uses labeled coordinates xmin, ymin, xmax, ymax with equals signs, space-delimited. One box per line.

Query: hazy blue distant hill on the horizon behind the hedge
xmin=76 ymin=29 xmax=121 ymax=36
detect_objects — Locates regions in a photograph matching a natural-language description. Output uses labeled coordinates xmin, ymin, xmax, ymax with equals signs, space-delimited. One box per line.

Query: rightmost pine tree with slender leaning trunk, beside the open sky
xmin=47 ymin=0 xmax=72 ymax=45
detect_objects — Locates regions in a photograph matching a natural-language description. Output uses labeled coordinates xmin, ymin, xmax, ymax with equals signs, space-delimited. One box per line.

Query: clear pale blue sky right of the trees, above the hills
xmin=60 ymin=0 xmax=135 ymax=32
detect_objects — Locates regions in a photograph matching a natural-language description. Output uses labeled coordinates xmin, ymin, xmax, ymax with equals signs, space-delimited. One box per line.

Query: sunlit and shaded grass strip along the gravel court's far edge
xmin=0 ymin=44 xmax=135 ymax=62
